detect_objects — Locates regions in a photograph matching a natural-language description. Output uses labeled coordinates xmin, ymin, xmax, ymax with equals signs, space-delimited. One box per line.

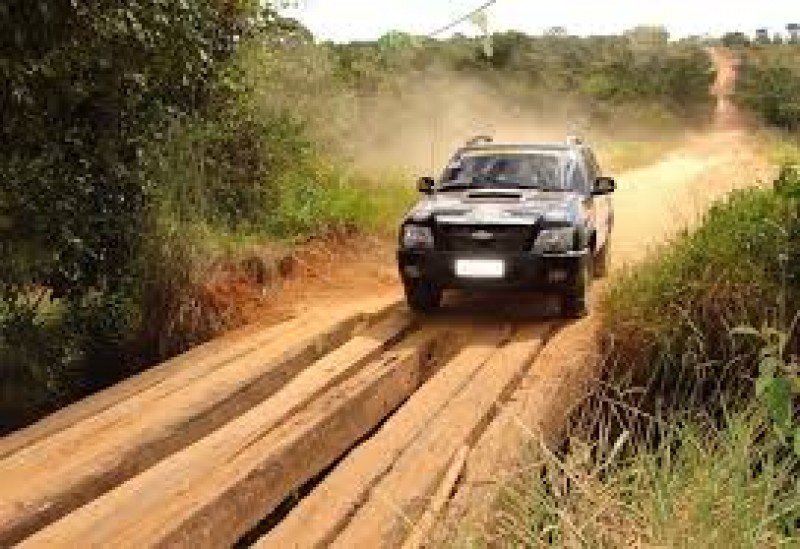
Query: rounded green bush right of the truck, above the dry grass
xmin=603 ymin=171 xmax=800 ymax=409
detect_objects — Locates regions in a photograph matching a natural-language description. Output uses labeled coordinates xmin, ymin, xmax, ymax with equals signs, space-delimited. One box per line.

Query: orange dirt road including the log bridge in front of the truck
xmin=0 ymin=49 xmax=768 ymax=547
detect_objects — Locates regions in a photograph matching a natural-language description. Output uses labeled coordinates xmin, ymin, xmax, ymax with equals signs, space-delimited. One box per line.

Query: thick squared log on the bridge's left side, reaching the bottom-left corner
xmin=0 ymin=298 xmax=400 ymax=545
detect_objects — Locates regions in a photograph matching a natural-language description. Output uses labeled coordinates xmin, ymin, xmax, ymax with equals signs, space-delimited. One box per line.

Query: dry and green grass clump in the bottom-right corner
xmin=484 ymin=412 xmax=800 ymax=549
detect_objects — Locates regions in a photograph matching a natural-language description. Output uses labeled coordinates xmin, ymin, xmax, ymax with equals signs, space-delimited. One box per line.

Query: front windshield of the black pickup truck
xmin=439 ymin=152 xmax=567 ymax=191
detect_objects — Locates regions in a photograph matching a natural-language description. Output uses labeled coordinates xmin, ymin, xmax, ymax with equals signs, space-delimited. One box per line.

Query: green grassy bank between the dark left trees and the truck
xmin=136 ymin=113 xmax=414 ymax=361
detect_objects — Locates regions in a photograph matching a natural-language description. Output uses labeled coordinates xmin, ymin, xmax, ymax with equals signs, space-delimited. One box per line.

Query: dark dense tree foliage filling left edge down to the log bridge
xmin=0 ymin=0 xmax=272 ymax=427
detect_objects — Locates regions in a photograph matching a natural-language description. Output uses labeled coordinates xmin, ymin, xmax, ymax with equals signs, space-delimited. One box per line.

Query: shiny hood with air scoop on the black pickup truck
xmin=407 ymin=189 xmax=582 ymax=225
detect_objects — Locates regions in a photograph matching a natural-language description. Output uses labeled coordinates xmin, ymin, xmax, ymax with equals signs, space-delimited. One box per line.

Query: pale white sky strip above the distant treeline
xmin=284 ymin=0 xmax=800 ymax=42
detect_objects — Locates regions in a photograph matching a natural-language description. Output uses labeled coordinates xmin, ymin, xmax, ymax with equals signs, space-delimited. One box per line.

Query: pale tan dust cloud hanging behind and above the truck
xmin=326 ymin=71 xmax=685 ymax=175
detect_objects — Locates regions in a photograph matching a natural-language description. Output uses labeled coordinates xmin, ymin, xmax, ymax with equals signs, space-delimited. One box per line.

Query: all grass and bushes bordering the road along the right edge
xmin=479 ymin=37 xmax=800 ymax=547
